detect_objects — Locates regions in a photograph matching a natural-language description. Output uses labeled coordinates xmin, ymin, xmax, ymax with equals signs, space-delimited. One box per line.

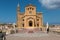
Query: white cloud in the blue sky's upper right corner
xmin=39 ymin=0 xmax=60 ymax=9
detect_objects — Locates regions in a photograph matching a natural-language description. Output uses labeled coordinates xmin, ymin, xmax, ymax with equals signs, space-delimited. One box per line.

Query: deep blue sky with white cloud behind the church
xmin=0 ymin=0 xmax=60 ymax=24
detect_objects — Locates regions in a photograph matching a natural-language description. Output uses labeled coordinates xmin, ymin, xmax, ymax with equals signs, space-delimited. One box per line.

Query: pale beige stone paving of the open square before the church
xmin=6 ymin=32 xmax=60 ymax=40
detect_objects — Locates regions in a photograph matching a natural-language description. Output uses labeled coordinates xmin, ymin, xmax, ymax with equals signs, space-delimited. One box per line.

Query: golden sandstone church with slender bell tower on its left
xmin=16 ymin=4 xmax=43 ymax=28
